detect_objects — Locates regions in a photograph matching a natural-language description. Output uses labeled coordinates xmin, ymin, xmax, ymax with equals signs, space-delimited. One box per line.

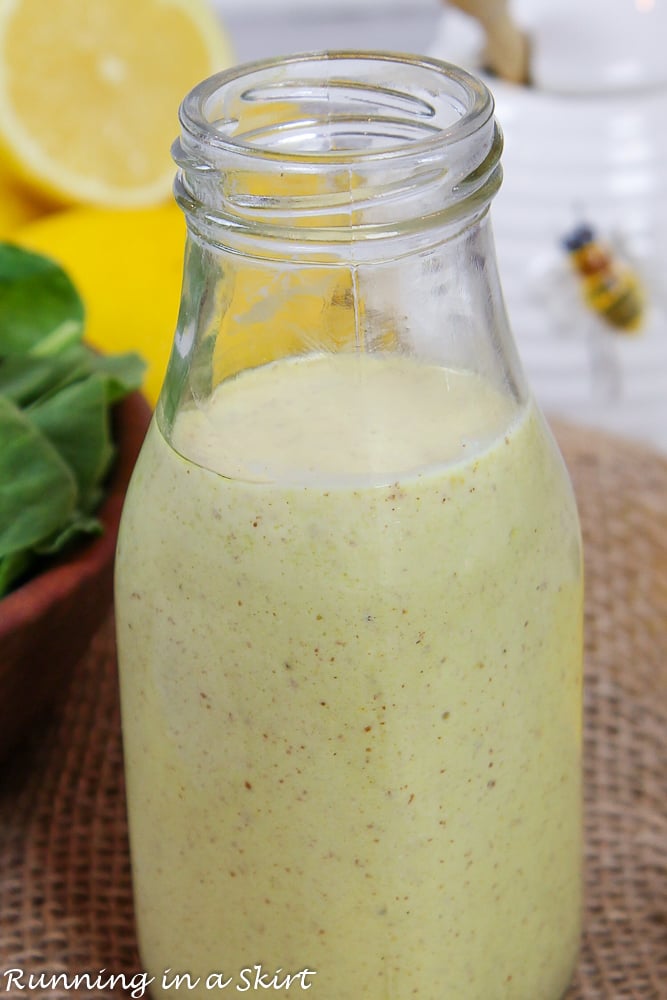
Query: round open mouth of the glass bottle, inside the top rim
xmin=180 ymin=52 xmax=493 ymax=167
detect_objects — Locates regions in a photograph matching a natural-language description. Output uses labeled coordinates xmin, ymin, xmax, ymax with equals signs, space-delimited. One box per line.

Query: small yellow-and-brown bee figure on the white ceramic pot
xmin=563 ymin=224 xmax=644 ymax=334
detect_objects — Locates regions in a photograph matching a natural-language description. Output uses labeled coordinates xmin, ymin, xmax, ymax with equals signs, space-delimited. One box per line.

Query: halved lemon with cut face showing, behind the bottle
xmin=0 ymin=0 xmax=233 ymax=207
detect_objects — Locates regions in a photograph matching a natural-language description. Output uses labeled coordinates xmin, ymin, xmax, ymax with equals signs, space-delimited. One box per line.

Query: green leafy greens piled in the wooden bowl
xmin=0 ymin=243 xmax=145 ymax=598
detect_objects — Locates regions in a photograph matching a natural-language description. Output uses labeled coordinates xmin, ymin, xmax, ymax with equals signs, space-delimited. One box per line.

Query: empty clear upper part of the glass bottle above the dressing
xmin=158 ymin=53 xmax=524 ymax=435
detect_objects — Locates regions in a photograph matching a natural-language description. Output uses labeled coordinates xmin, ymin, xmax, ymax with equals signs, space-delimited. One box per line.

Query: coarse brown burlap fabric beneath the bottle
xmin=0 ymin=418 xmax=667 ymax=1000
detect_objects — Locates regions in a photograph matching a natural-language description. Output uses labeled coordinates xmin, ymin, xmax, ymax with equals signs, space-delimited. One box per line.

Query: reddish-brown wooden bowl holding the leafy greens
xmin=0 ymin=392 xmax=151 ymax=759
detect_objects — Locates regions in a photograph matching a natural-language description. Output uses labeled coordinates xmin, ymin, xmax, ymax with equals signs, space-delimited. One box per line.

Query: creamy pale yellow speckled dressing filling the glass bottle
xmin=117 ymin=354 xmax=582 ymax=1000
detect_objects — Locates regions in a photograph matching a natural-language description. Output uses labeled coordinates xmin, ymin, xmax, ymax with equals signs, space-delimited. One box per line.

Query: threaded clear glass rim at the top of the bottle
xmin=172 ymin=52 xmax=502 ymax=256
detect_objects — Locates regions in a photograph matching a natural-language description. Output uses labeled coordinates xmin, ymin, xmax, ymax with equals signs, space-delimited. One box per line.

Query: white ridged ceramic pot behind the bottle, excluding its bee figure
xmin=431 ymin=0 xmax=667 ymax=451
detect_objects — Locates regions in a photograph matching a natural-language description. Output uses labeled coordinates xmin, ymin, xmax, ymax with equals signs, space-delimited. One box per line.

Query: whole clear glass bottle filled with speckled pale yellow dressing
xmin=117 ymin=53 xmax=582 ymax=1000
